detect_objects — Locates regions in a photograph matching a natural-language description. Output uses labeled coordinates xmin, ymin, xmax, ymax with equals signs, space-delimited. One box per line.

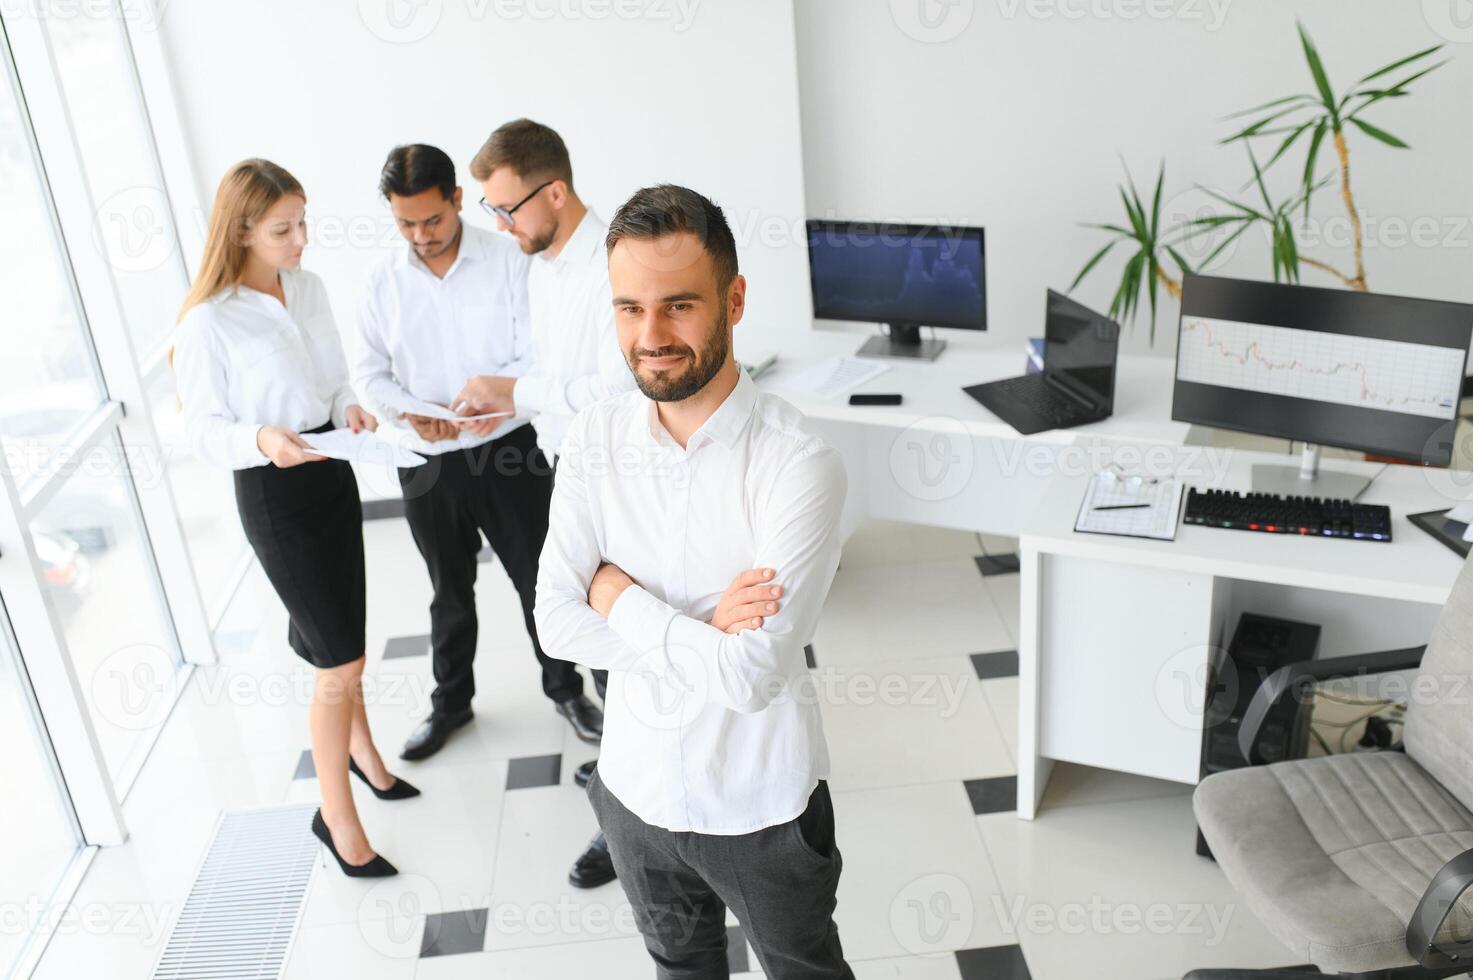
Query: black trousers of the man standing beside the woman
xmin=399 ymin=426 xmax=583 ymax=713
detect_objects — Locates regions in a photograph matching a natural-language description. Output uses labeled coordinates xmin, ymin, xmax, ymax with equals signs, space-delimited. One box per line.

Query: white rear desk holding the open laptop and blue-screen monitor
xmin=738 ymin=330 xmax=1189 ymax=538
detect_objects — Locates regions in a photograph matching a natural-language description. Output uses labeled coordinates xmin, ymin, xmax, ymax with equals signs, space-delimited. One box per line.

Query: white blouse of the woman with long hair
xmin=174 ymin=270 xmax=355 ymax=470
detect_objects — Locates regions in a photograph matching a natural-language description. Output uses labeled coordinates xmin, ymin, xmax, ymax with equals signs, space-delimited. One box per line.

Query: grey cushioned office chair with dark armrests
xmin=1187 ymin=563 xmax=1473 ymax=980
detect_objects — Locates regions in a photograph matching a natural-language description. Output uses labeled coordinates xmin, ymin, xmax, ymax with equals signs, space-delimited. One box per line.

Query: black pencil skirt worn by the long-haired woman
xmin=236 ymin=430 xmax=365 ymax=668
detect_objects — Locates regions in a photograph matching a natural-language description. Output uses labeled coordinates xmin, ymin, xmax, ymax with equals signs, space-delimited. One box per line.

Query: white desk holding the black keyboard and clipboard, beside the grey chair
xmin=1018 ymin=449 xmax=1469 ymax=818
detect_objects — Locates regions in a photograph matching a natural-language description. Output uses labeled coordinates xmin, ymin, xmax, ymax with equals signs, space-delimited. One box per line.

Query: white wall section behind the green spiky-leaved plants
xmin=797 ymin=0 xmax=1473 ymax=354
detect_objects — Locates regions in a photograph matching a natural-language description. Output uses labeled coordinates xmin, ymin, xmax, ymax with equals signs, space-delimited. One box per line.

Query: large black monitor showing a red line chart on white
xmin=1171 ymin=276 xmax=1473 ymax=498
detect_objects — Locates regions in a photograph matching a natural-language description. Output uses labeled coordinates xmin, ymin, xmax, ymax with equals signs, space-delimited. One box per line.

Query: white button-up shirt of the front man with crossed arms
xmin=536 ymin=371 xmax=847 ymax=834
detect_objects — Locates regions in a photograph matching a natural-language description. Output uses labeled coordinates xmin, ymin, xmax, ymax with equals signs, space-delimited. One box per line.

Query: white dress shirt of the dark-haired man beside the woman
xmin=354 ymin=223 xmax=532 ymax=454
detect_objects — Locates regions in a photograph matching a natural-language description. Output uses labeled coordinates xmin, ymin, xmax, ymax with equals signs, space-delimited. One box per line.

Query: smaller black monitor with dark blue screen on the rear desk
xmin=809 ymin=221 xmax=987 ymax=360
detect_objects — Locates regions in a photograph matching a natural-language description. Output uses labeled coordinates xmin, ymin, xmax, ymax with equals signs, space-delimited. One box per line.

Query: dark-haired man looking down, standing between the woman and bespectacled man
xmin=354 ymin=144 xmax=604 ymax=759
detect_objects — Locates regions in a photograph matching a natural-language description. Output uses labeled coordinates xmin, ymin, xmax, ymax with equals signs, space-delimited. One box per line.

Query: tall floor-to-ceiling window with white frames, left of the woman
xmin=0 ymin=9 xmax=223 ymax=977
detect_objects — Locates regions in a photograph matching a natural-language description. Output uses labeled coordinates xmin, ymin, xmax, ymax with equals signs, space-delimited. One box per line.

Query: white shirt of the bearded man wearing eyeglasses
xmin=511 ymin=209 xmax=635 ymax=460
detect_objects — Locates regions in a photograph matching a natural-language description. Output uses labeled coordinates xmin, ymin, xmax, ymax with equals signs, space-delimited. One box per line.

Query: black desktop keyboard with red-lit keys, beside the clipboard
xmin=1181 ymin=488 xmax=1391 ymax=541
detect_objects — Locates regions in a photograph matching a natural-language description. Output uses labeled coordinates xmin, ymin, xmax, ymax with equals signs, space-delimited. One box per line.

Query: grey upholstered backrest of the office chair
xmin=1402 ymin=551 xmax=1473 ymax=809
